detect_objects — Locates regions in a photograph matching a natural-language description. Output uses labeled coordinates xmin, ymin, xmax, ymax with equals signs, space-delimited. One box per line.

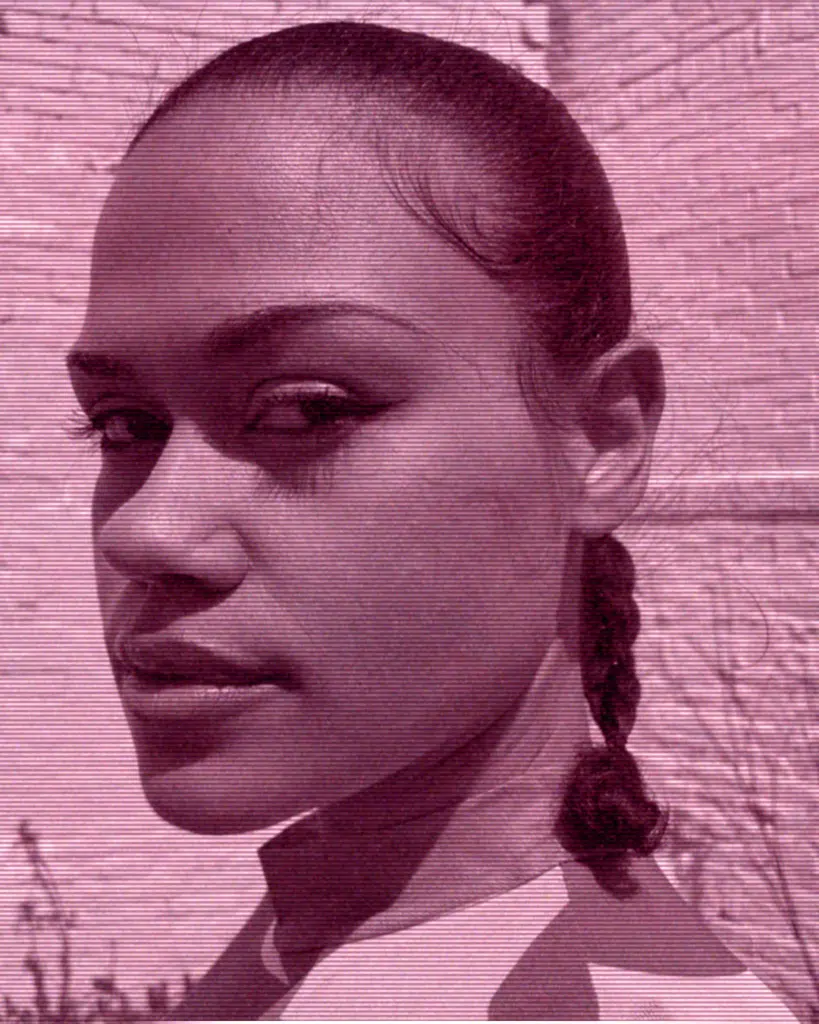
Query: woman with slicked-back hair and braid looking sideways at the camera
xmin=69 ymin=23 xmax=792 ymax=1021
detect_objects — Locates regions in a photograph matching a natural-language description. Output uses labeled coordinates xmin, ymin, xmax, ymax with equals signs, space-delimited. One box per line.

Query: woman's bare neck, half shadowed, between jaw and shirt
xmin=259 ymin=641 xmax=588 ymax=952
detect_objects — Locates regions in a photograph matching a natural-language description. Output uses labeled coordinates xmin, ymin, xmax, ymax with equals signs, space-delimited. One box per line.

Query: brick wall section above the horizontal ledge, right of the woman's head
xmin=563 ymin=0 xmax=819 ymax=487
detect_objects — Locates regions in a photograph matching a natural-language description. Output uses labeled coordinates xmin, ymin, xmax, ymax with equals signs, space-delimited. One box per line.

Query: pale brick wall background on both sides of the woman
xmin=0 ymin=0 xmax=819 ymax=1011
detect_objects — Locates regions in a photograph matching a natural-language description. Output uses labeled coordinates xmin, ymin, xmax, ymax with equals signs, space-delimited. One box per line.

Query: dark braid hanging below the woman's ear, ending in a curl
xmin=557 ymin=535 xmax=666 ymax=896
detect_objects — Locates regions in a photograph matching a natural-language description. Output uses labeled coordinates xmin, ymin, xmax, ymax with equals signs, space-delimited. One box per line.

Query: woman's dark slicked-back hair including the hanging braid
xmin=129 ymin=22 xmax=665 ymax=896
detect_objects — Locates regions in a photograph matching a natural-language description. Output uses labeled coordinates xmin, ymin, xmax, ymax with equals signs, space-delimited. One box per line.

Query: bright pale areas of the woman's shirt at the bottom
xmin=261 ymin=868 xmax=796 ymax=1024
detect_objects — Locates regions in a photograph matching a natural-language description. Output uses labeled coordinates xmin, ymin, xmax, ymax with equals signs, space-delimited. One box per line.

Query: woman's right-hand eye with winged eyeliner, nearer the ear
xmin=246 ymin=381 xmax=375 ymax=435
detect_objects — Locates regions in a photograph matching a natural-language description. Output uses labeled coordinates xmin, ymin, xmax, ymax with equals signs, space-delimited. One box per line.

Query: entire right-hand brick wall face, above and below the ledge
xmin=561 ymin=6 xmax=819 ymax=1017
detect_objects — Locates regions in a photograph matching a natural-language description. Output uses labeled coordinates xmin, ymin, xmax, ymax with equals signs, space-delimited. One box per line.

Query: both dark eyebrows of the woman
xmin=66 ymin=301 xmax=426 ymax=380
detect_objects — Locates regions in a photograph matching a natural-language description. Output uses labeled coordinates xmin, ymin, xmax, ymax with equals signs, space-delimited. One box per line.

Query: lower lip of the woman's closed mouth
xmin=120 ymin=672 xmax=286 ymax=722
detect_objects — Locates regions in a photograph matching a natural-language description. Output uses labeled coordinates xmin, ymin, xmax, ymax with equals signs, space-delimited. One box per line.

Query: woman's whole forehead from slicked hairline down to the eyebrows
xmin=83 ymin=95 xmax=522 ymax=372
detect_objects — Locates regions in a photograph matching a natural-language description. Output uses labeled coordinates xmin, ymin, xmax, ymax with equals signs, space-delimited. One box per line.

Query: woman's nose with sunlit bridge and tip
xmin=96 ymin=428 xmax=248 ymax=592
